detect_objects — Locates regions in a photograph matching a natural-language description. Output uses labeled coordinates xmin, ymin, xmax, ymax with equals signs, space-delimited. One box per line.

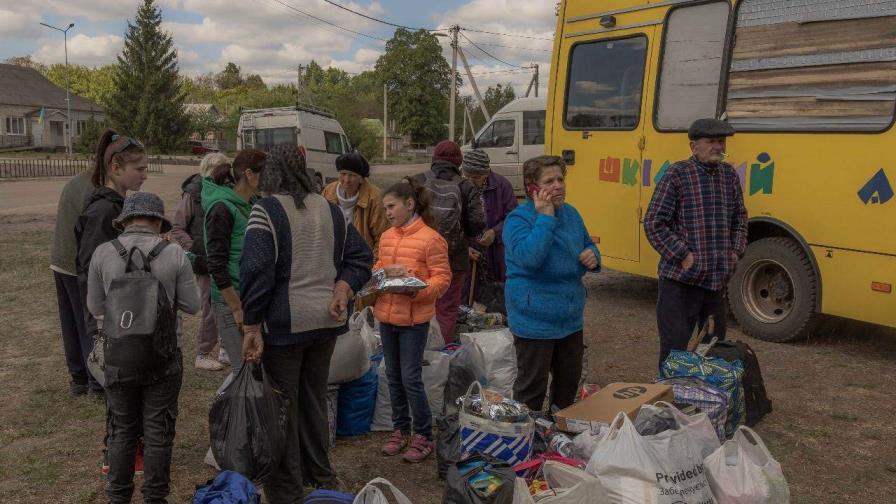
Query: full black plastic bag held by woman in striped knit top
xmin=208 ymin=362 xmax=289 ymax=482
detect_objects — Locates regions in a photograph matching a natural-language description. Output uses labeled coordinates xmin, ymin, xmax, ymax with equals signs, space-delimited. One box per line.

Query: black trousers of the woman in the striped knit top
xmin=262 ymin=336 xmax=336 ymax=504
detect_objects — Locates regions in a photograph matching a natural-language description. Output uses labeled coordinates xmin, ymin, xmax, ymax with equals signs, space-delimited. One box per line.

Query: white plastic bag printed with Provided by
xmin=585 ymin=412 xmax=716 ymax=504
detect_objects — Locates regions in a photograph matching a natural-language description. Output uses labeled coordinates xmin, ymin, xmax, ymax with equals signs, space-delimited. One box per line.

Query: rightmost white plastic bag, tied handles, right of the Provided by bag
xmin=704 ymin=425 xmax=790 ymax=504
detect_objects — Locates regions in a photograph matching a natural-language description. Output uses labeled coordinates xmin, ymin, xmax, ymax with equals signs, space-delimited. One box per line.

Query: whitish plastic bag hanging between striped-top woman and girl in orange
xmin=327 ymin=307 xmax=375 ymax=384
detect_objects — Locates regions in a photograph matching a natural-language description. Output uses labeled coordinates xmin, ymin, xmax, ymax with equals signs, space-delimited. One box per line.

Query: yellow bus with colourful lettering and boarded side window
xmin=545 ymin=0 xmax=896 ymax=341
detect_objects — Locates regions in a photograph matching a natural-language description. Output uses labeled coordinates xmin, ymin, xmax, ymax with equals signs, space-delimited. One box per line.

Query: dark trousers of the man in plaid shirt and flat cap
xmin=656 ymin=278 xmax=726 ymax=367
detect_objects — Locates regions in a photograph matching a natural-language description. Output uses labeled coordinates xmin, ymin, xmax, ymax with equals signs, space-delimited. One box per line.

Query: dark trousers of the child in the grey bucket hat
xmin=106 ymin=351 xmax=183 ymax=504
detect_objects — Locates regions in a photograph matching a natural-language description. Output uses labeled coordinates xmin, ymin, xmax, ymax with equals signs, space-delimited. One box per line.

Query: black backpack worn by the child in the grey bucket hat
xmin=103 ymin=240 xmax=177 ymax=386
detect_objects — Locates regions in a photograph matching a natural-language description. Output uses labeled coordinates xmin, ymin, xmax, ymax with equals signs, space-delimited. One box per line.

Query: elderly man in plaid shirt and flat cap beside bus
xmin=644 ymin=119 xmax=747 ymax=365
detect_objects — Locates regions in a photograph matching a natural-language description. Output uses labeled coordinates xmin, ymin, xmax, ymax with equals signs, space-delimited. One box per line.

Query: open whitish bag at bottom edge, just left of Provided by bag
xmin=513 ymin=460 xmax=610 ymax=504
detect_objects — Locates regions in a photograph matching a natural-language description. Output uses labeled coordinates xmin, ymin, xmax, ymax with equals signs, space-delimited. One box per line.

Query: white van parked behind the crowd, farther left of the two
xmin=236 ymin=104 xmax=351 ymax=187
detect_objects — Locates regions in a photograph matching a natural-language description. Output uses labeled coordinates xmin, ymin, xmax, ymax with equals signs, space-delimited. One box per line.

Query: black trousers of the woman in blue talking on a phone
xmin=513 ymin=331 xmax=585 ymax=411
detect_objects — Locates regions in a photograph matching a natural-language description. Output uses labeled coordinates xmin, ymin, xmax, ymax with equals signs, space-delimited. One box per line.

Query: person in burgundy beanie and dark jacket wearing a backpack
xmin=411 ymin=140 xmax=485 ymax=343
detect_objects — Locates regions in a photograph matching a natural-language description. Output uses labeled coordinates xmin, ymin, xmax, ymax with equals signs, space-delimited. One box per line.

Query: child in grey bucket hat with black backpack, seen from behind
xmin=87 ymin=192 xmax=200 ymax=503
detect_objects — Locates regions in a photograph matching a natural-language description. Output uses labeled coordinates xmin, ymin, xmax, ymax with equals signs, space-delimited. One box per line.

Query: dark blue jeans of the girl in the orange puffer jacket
xmin=380 ymin=322 xmax=432 ymax=439
